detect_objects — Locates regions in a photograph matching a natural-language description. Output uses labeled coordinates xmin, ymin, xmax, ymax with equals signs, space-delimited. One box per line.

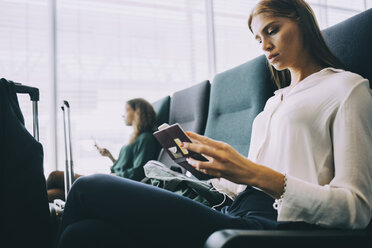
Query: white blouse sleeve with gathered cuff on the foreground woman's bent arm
xmin=278 ymin=79 xmax=372 ymax=229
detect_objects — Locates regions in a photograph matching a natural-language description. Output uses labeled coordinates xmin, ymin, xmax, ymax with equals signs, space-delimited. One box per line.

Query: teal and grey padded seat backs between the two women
xmin=153 ymin=56 xmax=276 ymax=172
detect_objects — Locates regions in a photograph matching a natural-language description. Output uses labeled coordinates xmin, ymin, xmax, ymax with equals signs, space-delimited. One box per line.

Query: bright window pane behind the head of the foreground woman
xmin=214 ymin=0 xmax=372 ymax=72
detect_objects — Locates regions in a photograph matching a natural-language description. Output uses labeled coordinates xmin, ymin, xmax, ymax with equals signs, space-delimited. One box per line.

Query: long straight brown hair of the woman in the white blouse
xmin=248 ymin=0 xmax=345 ymax=88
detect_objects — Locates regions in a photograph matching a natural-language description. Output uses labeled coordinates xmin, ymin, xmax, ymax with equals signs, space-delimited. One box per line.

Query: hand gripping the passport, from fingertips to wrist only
xmin=183 ymin=132 xmax=259 ymax=185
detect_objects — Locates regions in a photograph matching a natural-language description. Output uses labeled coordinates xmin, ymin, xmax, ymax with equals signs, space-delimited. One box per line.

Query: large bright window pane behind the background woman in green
xmin=57 ymin=0 xmax=208 ymax=174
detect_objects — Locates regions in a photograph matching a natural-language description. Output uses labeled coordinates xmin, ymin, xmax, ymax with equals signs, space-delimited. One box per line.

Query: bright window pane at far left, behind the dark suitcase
xmin=0 ymin=0 xmax=56 ymax=173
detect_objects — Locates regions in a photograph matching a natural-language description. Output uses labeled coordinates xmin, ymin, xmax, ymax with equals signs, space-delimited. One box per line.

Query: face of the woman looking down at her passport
xmin=251 ymin=14 xmax=305 ymax=71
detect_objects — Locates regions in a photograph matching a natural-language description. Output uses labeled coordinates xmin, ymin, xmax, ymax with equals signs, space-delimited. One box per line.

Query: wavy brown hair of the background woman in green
xmin=127 ymin=98 xmax=156 ymax=143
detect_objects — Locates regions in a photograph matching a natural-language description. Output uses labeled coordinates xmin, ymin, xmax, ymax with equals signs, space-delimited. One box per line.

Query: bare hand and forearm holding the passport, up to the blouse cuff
xmin=182 ymin=132 xmax=284 ymax=198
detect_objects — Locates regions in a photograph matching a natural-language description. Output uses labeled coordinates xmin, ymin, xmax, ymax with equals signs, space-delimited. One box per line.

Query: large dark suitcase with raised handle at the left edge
xmin=0 ymin=79 xmax=51 ymax=247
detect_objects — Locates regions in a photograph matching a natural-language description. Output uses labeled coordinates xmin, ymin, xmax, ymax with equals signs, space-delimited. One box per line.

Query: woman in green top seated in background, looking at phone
xmin=47 ymin=98 xmax=160 ymax=202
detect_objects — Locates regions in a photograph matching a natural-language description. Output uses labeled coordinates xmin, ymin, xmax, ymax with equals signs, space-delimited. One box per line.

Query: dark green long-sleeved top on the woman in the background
xmin=111 ymin=132 xmax=160 ymax=181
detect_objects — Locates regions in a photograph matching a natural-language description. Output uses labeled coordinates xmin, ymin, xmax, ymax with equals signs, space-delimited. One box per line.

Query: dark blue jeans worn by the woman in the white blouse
xmin=58 ymin=175 xmax=306 ymax=247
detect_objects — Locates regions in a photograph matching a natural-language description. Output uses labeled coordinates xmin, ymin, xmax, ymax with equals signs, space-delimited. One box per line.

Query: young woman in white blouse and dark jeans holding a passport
xmin=58 ymin=0 xmax=372 ymax=247
